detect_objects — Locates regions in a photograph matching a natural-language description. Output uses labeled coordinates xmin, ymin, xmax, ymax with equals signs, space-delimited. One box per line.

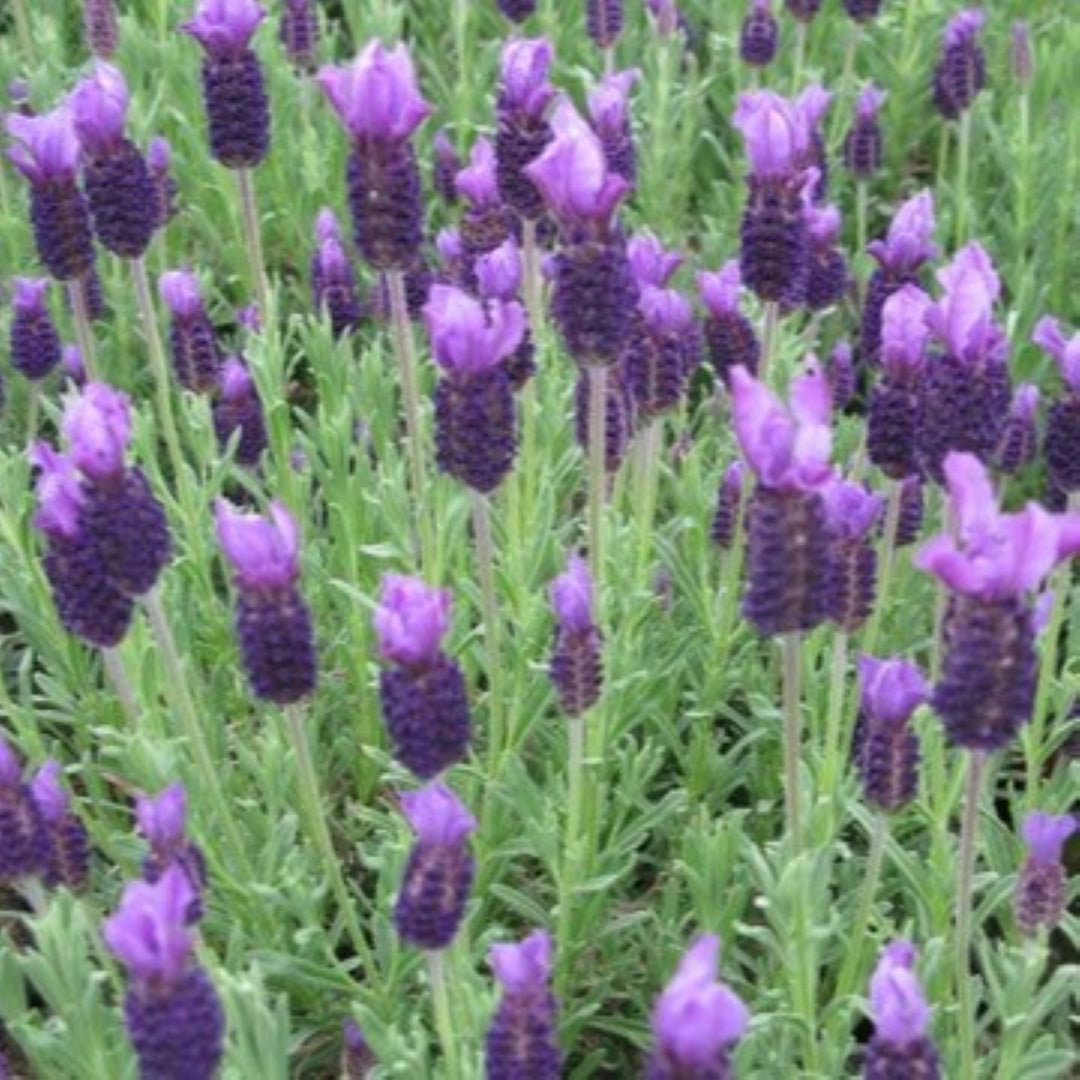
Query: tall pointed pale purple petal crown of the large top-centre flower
xmin=525 ymin=98 xmax=629 ymax=227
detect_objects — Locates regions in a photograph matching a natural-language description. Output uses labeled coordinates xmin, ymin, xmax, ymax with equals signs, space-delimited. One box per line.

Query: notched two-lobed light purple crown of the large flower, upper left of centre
xmin=423 ymin=285 xmax=525 ymax=375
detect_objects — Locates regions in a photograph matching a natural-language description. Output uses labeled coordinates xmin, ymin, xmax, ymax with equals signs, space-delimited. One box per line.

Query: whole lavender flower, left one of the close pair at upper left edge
xmin=4 ymin=104 xmax=94 ymax=281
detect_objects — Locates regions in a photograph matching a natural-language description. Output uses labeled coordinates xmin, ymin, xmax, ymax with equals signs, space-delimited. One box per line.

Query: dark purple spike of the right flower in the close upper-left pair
xmin=82 ymin=139 xmax=158 ymax=259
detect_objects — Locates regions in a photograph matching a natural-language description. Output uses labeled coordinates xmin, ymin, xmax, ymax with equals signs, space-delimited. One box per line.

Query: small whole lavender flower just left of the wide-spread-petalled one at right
xmin=851 ymin=656 xmax=930 ymax=813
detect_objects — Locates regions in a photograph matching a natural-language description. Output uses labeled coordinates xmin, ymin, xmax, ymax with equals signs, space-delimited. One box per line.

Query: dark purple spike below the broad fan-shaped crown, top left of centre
xmin=346 ymin=143 xmax=423 ymax=270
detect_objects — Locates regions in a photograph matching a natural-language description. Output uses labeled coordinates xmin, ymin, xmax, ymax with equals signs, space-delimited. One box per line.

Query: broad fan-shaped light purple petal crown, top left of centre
xmin=315 ymin=40 xmax=431 ymax=143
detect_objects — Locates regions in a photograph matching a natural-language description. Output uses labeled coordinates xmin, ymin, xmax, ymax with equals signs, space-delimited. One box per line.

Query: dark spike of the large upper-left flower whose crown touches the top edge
xmin=202 ymin=49 xmax=270 ymax=168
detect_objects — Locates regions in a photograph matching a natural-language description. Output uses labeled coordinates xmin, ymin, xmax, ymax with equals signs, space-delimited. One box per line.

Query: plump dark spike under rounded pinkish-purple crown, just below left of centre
xmin=379 ymin=654 xmax=472 ymax=780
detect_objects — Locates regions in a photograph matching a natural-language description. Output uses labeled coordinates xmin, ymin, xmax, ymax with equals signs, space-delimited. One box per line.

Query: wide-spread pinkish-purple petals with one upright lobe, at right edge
xmin=914 ymin=451 xmax=1080 ymax=599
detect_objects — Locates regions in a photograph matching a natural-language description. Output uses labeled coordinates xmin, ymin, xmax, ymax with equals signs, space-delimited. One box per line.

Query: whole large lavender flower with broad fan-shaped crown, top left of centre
xmin=316 ymin=41 xmax=431 ymax=270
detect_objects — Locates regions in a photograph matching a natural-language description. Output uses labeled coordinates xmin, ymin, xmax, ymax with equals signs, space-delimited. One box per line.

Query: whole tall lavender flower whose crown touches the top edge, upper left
xmin=180 ymin=0 xmax=270 ymax=168
